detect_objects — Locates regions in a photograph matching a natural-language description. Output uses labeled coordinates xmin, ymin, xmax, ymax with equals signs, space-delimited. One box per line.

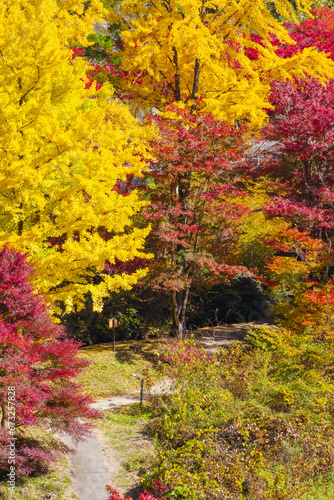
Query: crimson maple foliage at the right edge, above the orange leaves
xmin=260 ymin=8 xmax=334 ymax=242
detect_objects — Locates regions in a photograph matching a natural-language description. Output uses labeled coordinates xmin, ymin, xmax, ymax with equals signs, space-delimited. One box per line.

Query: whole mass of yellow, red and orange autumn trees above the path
xmin=0 ymin=0 xmax=334 ymax=486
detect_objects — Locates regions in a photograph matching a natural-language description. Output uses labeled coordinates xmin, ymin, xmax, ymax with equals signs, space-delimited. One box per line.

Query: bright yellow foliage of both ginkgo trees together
xmin=0 ymin=0 xmax=334 ymax=311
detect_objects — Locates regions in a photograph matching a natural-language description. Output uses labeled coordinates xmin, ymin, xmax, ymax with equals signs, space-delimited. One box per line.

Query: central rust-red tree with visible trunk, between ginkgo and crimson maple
xmin=145 ymin=107 xmax=250 ymax=338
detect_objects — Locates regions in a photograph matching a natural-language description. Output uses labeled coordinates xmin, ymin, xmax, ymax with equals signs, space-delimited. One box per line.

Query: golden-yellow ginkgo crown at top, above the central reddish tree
xmin=111 ymin=0 xmax=334 ymax=128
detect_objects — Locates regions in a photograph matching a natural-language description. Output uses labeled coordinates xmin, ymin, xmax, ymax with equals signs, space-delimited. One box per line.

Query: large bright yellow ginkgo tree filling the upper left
xmin=0 ymin=0 xmax=148 ymax=311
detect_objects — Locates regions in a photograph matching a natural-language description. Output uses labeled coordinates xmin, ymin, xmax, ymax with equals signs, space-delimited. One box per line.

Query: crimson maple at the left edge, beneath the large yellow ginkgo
xmin=0 ymin=247 xmax=97 ymax=475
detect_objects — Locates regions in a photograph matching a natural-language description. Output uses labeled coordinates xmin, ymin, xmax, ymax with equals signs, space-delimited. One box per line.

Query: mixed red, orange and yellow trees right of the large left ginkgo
xmin=85 ymin=0 xmax=333 ymax=337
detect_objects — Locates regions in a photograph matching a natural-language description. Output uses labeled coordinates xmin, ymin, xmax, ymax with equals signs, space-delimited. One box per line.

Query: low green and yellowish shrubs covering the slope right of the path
xmin=145 ymin=327 xmax=334 ymax=500
